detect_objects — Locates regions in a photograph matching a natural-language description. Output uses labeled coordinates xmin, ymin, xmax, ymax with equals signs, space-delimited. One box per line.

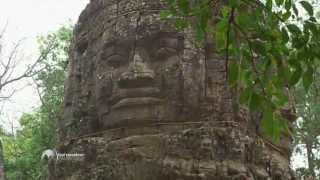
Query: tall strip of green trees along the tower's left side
xmin=4 ymin=26 xmax=72 ymax=180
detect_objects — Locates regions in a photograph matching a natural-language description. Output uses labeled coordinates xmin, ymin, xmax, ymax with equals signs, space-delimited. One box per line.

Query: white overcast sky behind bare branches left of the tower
xmin=0 ymin=0 xmax=89 ymax=130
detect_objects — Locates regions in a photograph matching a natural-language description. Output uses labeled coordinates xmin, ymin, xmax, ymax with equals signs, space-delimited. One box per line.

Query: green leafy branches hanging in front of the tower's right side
xmin=161 ymin=0 xmax=320 ymax=139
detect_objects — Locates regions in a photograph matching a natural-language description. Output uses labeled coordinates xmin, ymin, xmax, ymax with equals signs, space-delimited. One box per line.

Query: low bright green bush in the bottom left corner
xmin=4 ymin=113 xmax=54 ymax=179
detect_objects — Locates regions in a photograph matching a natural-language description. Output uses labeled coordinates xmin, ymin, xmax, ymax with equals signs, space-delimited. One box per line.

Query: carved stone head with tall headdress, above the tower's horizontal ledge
xmin=60 ymin=0 xmax=209 ymax=136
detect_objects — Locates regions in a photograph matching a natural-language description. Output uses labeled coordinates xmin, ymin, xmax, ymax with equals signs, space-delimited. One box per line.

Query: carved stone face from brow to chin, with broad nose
xmin=96 ymin=31 xmax=205 ymax=128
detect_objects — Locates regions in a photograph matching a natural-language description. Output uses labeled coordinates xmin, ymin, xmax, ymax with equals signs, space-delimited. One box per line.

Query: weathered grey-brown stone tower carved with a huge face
xmin=52 ymin=0 xmax=294 ymax=180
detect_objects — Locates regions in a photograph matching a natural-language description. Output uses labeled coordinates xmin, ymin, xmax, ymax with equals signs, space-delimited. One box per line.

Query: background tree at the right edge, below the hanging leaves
xmin=294 ymin=70 xmax=320 ymax=178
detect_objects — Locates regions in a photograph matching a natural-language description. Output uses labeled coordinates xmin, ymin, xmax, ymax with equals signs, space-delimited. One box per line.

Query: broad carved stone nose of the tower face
xmin=119 ymin=54 xmax=154 ymax=88
